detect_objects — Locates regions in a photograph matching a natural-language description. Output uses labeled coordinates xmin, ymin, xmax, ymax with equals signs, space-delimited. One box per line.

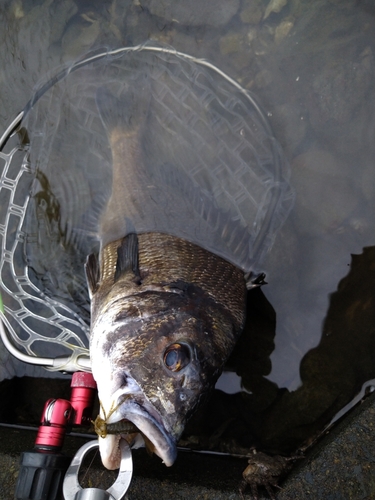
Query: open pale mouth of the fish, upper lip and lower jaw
xmin=99 ymin=395 xmax=177 ymax=470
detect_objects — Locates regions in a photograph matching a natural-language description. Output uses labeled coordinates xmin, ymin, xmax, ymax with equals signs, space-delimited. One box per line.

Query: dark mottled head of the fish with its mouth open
xmin=90 ymin=287 xmax=241 ymax=469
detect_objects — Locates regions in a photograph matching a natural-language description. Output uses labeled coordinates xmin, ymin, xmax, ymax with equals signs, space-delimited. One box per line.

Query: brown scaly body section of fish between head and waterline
xmin=93 ymin=233 xmax=246 ymax=332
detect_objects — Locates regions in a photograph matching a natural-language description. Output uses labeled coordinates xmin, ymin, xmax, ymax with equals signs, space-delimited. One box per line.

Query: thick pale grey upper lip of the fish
xmin=102 ymin=398 xmax=177 ymax=467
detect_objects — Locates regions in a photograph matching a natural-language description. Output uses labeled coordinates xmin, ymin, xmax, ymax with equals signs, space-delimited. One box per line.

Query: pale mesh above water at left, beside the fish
xmin=0 ymin=138 xmax=88 ymax=357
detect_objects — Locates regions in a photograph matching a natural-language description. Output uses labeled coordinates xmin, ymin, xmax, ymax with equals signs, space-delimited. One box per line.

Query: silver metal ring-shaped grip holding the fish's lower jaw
xmin=63 ymin=439 xmax=133 ymax=500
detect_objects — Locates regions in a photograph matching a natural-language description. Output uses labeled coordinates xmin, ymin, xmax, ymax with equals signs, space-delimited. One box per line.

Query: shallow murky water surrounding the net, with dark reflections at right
xmin=0 ymin=0 xmax=375 ymax=451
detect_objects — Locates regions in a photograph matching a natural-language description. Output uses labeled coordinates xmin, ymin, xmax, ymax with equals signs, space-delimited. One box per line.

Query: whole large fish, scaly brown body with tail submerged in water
xmin=86 ymin=89 xmax=247 ymax=469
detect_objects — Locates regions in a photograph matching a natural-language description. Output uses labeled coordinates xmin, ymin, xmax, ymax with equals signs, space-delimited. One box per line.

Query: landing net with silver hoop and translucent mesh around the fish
xmin=0 ymin=45 xmax=293 ymax=371
